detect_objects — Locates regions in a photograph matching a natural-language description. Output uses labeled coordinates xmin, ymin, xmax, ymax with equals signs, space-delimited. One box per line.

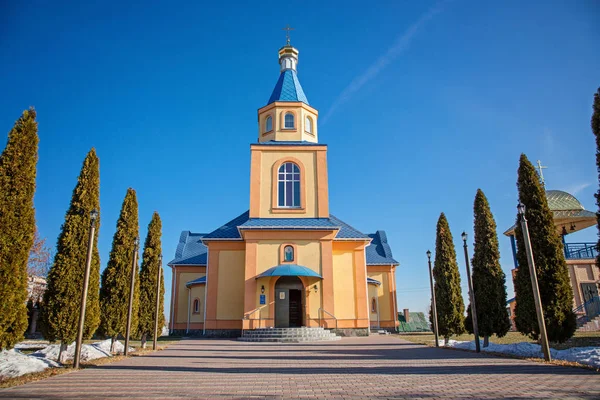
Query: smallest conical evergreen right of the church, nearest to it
xmin=433 ymin=213 xmax=465 ymax=343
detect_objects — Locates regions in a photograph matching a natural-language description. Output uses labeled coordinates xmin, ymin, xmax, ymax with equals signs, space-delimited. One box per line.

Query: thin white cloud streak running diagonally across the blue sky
xmin=323 ymin=1 xmax=447 ymax=123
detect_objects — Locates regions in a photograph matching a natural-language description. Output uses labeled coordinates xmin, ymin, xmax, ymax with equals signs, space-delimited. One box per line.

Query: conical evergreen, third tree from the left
xmin=100 ymin=188 xmax=139 ymax=352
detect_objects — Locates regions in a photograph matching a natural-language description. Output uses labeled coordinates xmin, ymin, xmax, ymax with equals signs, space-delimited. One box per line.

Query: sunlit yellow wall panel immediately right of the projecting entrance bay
xmin=333 ymin=250 xmax=356 ymax=319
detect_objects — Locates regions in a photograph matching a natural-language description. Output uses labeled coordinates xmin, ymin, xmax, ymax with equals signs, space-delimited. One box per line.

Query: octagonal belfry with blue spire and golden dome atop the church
xmin=258 ymin=41 xmax=319 ymax=143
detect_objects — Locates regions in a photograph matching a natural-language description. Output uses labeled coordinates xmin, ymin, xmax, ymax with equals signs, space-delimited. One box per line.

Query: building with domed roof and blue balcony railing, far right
xmin=504 ymin=190 xmax=600 ymax=325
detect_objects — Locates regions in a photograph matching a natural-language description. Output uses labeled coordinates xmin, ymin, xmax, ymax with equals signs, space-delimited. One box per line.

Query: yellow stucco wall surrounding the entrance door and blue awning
xmin=253 ymin=240 xmax=322 ymax=319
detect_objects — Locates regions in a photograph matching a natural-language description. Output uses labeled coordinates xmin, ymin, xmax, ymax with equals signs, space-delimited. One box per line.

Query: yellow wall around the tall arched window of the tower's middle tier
xmin=259 ymin=151 xmax=317 ymax=218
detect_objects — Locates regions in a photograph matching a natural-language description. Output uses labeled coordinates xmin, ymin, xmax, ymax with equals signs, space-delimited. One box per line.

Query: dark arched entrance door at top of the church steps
xmin=275 ymin=276 xmax=304 ymax=328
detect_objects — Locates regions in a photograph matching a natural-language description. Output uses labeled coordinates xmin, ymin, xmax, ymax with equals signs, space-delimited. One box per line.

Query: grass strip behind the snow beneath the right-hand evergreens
xmin=398 ymin=332 xmax=600 ymax=350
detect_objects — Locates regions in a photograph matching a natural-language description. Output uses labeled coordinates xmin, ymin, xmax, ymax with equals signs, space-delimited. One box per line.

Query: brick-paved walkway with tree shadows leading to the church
xmin=0 ymin=336 xmax=600 ymax=399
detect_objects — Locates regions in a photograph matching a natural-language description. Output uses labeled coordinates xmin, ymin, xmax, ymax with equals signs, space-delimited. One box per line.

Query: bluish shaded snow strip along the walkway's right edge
xmin=440 ymin=340 xmax=600 ymax=368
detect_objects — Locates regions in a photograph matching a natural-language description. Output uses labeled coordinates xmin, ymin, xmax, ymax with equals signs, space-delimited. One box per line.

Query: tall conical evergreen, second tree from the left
xmin=41 ymin=148 xmax=100 ymax=362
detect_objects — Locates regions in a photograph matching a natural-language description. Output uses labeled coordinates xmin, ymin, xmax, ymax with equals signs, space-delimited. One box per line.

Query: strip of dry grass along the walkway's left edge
xmin=0 ymin=337 xmax=179 ymax=389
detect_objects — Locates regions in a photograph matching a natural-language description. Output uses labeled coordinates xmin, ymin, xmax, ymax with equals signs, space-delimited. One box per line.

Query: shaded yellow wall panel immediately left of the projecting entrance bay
xmin=217 ymin=250 xmax=245 ymax=321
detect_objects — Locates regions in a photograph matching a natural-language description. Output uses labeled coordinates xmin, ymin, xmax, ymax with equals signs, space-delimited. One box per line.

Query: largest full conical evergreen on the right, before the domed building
xmin=514 ymin=154 xmax=577 ymax=342
